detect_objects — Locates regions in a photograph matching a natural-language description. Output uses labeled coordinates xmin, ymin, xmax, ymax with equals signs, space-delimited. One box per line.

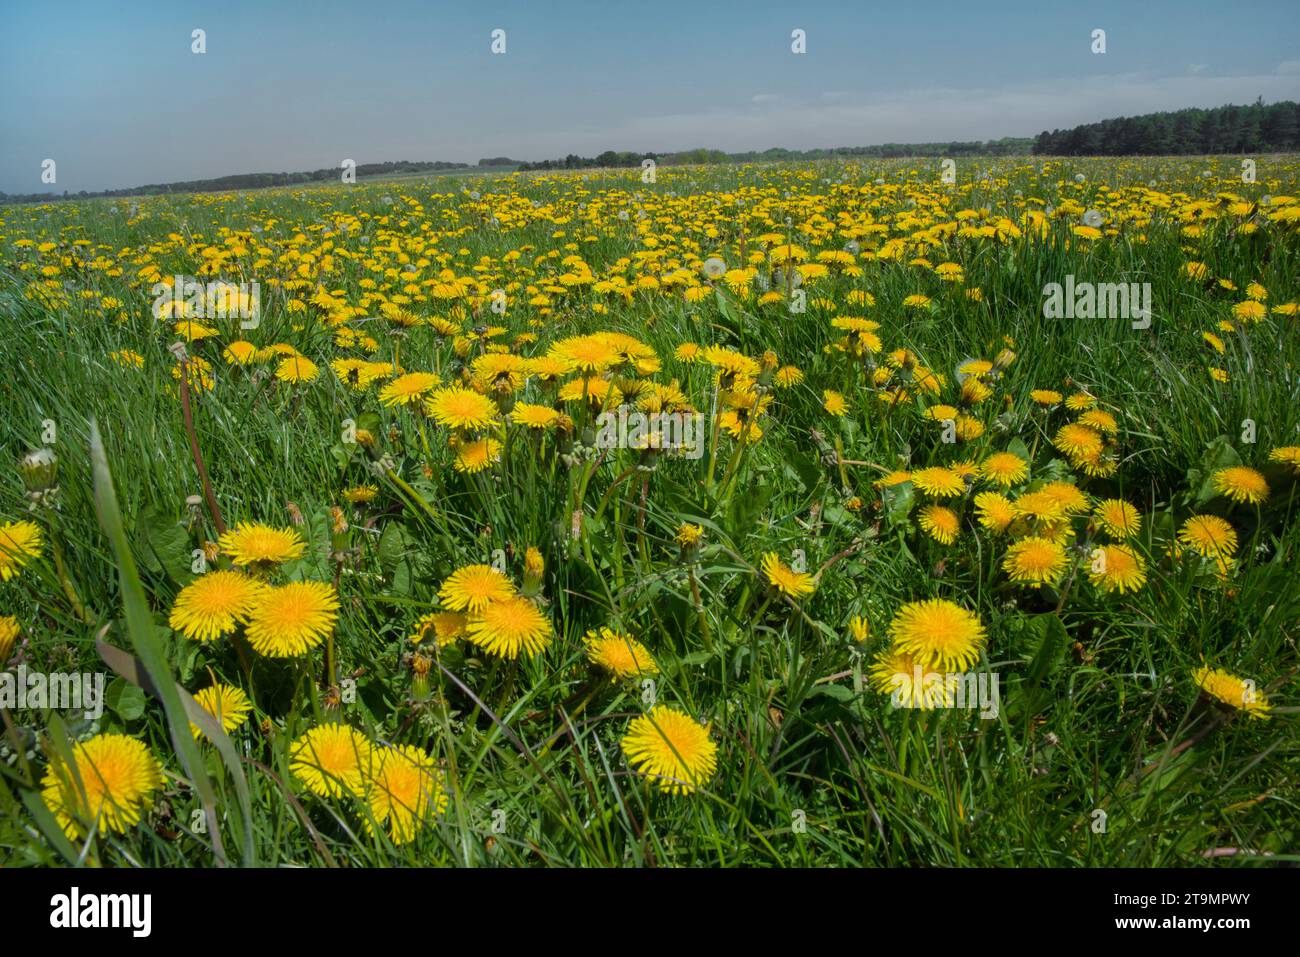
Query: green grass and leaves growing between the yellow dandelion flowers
xmin=0 ymin=157 xmax=1300 ymax=866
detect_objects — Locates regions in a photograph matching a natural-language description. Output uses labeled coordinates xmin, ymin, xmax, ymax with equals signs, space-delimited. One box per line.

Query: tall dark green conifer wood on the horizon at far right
xmin=1034 ymin=98 xmax=1300 ymax=156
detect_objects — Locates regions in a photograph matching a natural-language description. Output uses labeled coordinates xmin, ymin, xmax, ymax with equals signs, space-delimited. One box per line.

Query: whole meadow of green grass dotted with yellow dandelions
xmin=0 ymin=156 xmax=1300 ymax=866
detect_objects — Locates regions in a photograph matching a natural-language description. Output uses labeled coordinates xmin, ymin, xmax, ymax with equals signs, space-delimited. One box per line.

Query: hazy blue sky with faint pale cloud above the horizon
xmin=0 ymin=0 xmax=1300 ymax=192
